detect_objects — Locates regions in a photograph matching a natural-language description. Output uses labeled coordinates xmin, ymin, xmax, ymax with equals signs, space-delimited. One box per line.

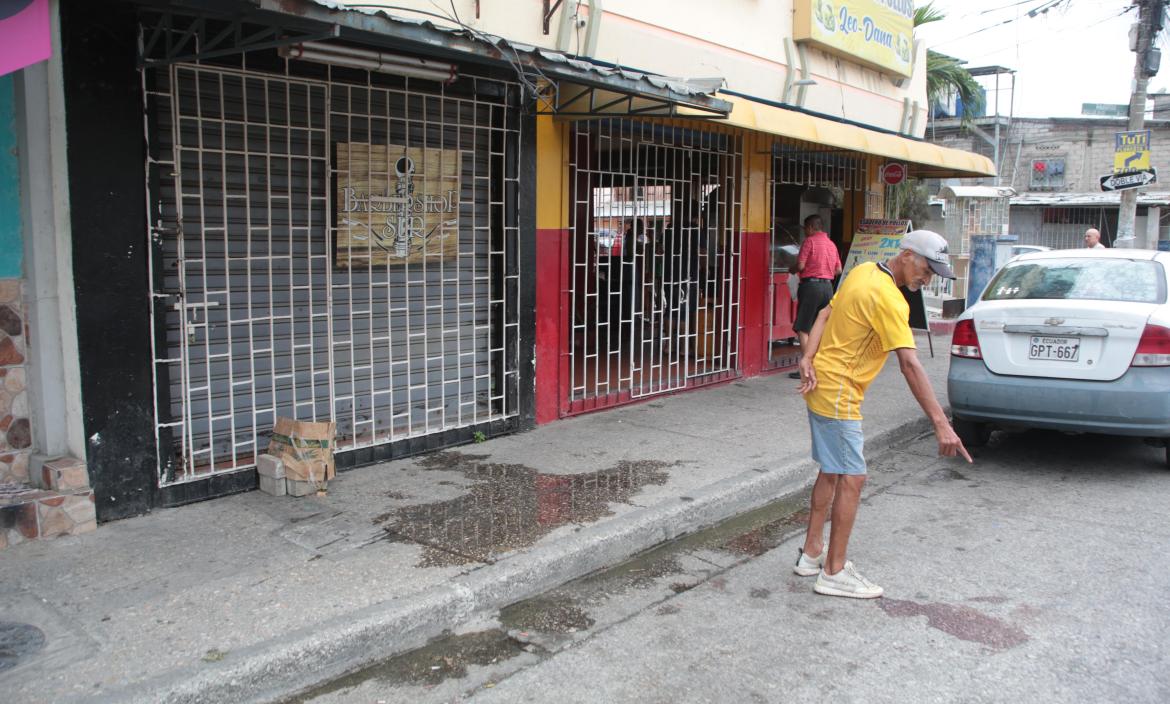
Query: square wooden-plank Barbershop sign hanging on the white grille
xmin=333 ymin=142 xmax=462 ymax=268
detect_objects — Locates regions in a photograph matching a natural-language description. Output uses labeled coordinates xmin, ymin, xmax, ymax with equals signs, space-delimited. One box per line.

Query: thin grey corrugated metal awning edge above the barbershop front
xmin=307 ymin=0 xmax=723 ymax=97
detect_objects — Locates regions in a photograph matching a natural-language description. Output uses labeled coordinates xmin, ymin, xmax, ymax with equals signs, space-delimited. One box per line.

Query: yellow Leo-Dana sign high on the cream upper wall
xmin=792 ymin=0 xmax=914 ymax=77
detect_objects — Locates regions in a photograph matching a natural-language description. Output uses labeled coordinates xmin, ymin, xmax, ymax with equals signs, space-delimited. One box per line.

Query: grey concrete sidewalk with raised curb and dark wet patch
xmin=0 ymin=334 xmax=948 ymax=702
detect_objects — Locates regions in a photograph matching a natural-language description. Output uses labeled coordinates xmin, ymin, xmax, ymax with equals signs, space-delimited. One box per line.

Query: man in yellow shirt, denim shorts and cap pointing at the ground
xmin=793 ymin=230 xmax=971 ymax=599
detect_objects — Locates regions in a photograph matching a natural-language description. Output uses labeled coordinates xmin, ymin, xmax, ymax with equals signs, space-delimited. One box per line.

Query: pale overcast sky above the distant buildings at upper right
xmin=915 ymin=0 xmax=1170 ymax=117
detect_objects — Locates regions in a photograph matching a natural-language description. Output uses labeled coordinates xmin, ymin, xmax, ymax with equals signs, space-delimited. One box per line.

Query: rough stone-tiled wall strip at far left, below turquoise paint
xmin=0 ymin=278 xmax=33 ymax=483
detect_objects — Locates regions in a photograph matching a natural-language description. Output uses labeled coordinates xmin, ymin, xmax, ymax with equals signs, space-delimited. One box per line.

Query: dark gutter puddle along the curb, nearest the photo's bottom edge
xmin=288 ymin=630 xmax=525 ymax=704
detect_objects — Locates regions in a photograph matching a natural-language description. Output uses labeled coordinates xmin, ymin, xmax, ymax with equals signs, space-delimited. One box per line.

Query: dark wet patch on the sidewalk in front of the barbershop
xmin=374 ymin=451 xmax=670 ymax=567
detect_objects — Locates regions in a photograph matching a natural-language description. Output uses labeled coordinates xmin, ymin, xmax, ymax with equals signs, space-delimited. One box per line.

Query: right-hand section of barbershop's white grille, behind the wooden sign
xmin=330 ymin=76 xmax=519 ymax=448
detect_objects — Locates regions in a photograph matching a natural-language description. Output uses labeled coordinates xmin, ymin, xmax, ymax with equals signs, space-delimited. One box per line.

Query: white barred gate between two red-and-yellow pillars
xmin=564 ymin=119 xmax=739 ymax=413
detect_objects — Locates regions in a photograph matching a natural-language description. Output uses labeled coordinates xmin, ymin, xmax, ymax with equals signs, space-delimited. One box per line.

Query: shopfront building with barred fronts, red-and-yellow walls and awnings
xmin=0 ymin=0 xmax=993 ymax=535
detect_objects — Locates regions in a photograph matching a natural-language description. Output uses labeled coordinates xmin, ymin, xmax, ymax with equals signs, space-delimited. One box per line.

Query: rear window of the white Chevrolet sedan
xmin=983 ymin=257 xmax=1166 ymax=303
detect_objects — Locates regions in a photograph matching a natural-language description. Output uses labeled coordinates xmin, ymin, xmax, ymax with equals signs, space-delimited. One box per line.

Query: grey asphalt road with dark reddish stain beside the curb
xmin=294 ymin=432 xmax=1170 ymax=703
